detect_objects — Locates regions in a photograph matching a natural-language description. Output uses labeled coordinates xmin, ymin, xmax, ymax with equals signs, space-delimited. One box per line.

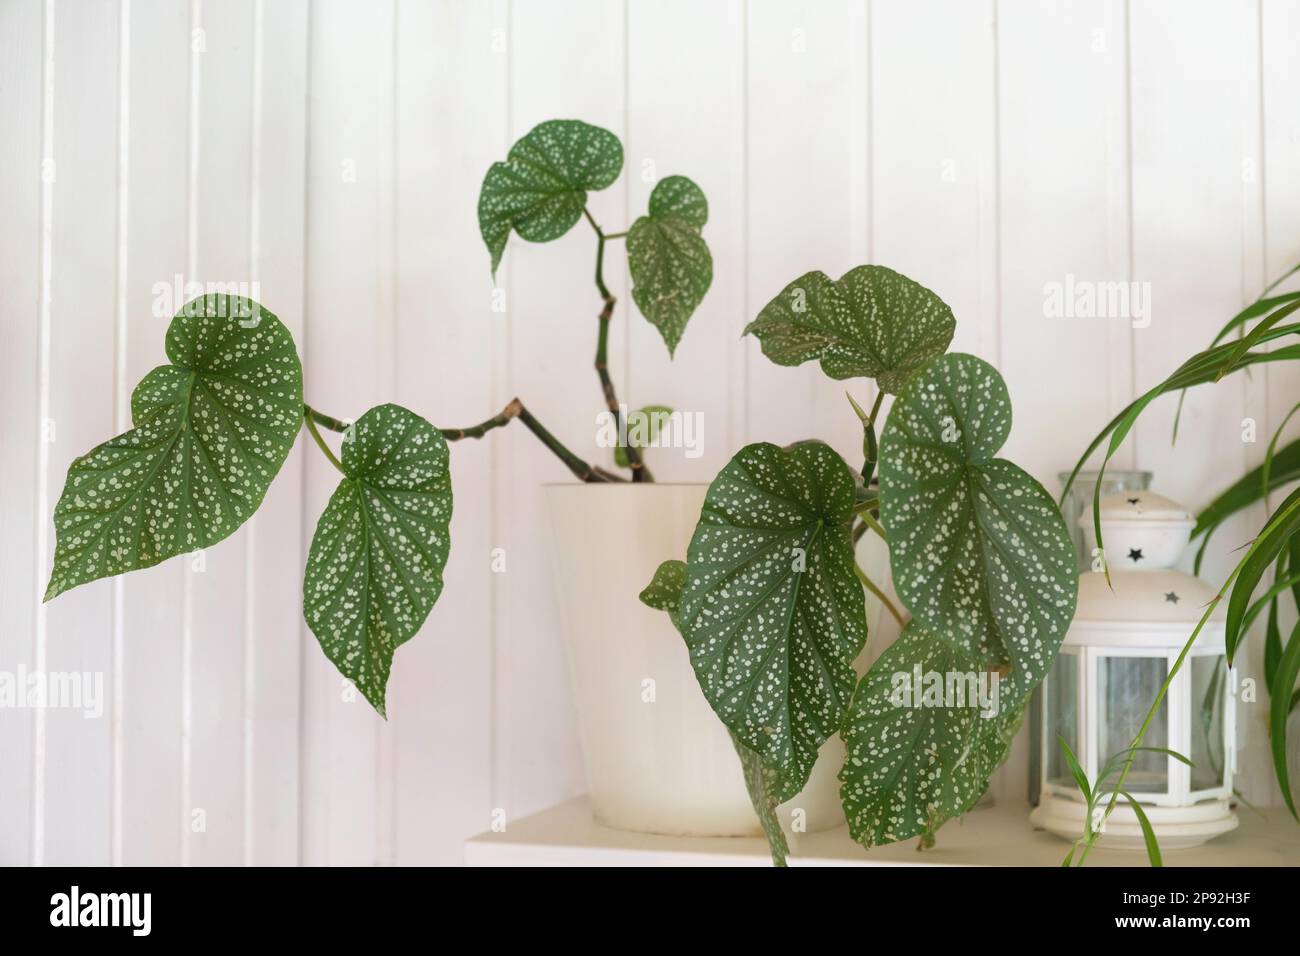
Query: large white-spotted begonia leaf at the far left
xmin=46 ymin=295 xmax=303 ymax=601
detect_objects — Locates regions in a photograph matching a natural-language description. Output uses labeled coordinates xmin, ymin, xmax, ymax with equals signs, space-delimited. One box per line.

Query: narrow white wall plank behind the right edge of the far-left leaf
xmin=243 ymin=0 xmax=306 ymax=866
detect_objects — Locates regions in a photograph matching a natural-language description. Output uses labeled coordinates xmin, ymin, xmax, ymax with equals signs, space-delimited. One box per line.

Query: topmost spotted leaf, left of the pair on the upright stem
xmin=478 ymin=120 xmax=623 ymax=273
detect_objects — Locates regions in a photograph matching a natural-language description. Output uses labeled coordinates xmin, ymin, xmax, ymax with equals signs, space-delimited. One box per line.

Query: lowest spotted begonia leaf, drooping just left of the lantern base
xmin=840 ymin=620 xmax=1044 ymax=847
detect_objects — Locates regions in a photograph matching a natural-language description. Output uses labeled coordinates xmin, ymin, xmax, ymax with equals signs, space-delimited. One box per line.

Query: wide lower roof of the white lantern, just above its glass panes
xmin=1074 ymin=570 xmax=1225 ymax=640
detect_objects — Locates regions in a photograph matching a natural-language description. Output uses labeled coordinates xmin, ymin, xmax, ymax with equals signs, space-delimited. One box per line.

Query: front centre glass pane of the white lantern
xmin=1097 ymin=657 xmax=1169 ymax=793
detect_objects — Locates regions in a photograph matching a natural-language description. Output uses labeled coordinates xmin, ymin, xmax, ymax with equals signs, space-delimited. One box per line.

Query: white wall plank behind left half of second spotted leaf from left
xmin=302 ymin=1 xmax=404 ymax=865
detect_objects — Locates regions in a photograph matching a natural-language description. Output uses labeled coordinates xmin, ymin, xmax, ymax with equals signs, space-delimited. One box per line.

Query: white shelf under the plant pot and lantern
xmin=465 ymin=797 xmax=1300 ymax=866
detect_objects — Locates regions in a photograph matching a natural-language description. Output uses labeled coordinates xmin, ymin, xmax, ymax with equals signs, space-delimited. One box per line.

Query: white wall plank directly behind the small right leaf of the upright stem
xmin=626 ymin=0 xmax=748 ymax=481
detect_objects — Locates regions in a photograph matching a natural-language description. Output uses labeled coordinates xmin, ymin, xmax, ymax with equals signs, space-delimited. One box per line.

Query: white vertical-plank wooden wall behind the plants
xmin=0 ymin=0 xmax=1300 ymax=864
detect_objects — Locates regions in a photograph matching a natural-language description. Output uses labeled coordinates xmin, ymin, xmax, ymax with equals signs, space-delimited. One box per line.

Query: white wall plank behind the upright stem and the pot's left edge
xmin=497 ymin=0 xmax=627 ymax=819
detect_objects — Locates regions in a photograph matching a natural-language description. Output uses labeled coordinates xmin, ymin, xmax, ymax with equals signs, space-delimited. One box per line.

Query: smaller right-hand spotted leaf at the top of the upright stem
xmin=628 ymin=176 xmax=714 ymax=355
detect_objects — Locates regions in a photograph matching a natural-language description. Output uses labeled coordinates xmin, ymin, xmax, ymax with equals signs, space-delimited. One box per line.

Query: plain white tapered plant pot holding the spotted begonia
xmin=545 ymin=483 xmax=845 ymax=836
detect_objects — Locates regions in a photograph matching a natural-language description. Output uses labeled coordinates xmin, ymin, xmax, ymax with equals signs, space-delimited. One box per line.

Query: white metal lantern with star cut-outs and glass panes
xmin=1030 ymin=492 xmax=1236 ymax=849
